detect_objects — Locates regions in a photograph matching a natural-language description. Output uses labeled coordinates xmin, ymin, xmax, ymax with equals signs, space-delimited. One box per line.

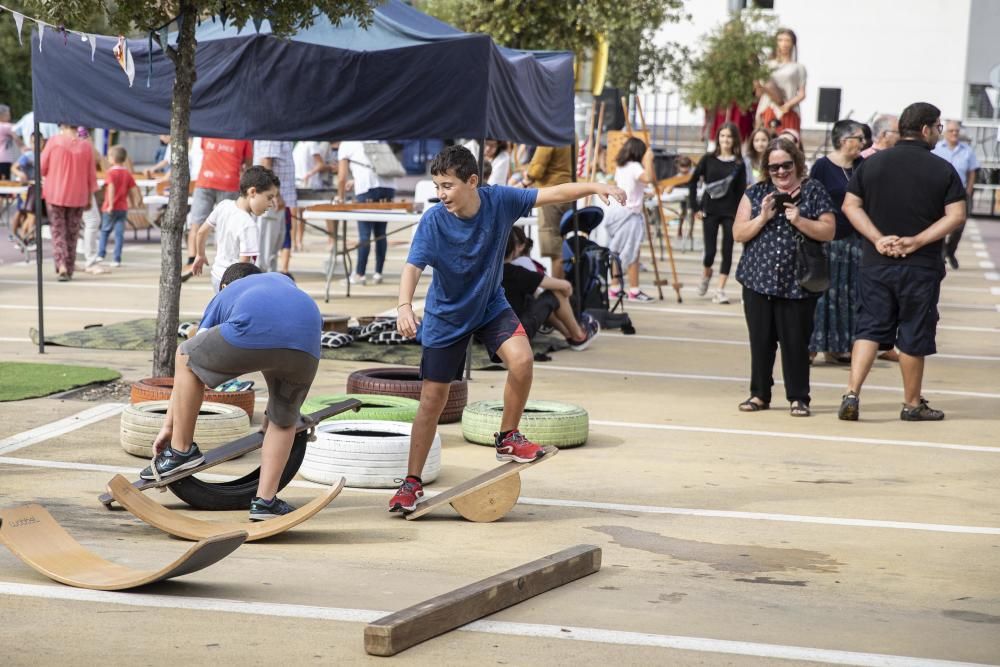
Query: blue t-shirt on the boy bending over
xmin=198 ymin=273 xmax=323 ymax=359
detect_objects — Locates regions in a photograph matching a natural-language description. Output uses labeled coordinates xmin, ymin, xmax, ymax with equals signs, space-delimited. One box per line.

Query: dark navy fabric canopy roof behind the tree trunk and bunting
xmin=32 ymin=0 xmax=574 ymax=146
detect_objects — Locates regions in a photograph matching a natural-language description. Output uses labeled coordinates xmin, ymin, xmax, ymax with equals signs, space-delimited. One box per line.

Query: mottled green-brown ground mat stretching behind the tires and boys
xmin=29 ymin=319 xmax=569 ymax=370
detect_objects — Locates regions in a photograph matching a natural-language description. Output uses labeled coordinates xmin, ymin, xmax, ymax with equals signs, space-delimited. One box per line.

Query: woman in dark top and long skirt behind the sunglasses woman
xmin=809 ymin=120 xmax=865 ymax=364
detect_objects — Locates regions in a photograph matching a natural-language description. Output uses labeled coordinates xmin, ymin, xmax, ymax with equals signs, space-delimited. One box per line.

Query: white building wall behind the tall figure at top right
xmin=657 ymin=0 xmax=988 ymax=128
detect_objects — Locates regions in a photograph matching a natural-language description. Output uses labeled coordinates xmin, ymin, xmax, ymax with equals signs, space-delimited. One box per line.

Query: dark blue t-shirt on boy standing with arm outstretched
xmin=406 ymin=185 xmax=538 ymax=348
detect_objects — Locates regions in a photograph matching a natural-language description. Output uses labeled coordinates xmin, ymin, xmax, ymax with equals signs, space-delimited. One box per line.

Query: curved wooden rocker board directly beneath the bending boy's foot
xmin=108 ymin=475 xmax=347 ymax=542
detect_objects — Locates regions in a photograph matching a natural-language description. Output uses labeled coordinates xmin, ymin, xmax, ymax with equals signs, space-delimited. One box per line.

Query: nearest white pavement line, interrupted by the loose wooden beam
xmin=0 ymin=581 xmax=982 ymax=667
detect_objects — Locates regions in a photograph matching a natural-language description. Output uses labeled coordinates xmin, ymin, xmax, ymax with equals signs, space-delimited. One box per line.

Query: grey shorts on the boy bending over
xmin=178 ymin=327 xmax=319 ymax=427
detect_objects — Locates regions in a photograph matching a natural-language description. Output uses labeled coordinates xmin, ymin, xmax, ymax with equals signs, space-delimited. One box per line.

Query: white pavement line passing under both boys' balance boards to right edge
xmin=0 ymin=456 xmax=1000 ymax=535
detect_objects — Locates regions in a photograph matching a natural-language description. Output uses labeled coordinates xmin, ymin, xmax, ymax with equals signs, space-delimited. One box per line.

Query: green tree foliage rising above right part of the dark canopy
xmin=415 ymin=0 xmax=685 ymax=90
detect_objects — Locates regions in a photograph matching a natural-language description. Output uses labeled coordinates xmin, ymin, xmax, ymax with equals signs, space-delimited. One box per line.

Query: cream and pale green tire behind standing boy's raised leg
xmin=462 ymin=400 xmax=590 ymax=449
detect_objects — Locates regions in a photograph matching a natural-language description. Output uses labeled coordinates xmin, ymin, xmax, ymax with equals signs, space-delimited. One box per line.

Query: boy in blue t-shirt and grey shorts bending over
xmin=139 ymin=262 xmax=323 ymax=521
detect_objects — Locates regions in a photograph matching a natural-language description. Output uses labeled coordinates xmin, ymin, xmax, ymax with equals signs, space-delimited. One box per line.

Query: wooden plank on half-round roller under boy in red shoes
xmin=405 ymin=447 xmax=559 ymax=523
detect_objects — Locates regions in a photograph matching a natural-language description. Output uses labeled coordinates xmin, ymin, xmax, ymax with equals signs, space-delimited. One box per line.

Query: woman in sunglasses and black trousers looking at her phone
xmin=733 ymin=137 xmax=835 ymax=417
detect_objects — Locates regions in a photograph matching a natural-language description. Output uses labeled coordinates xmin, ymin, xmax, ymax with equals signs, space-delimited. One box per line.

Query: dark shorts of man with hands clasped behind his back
xmin=854 ymin=264 xmax=941 ymax=357
